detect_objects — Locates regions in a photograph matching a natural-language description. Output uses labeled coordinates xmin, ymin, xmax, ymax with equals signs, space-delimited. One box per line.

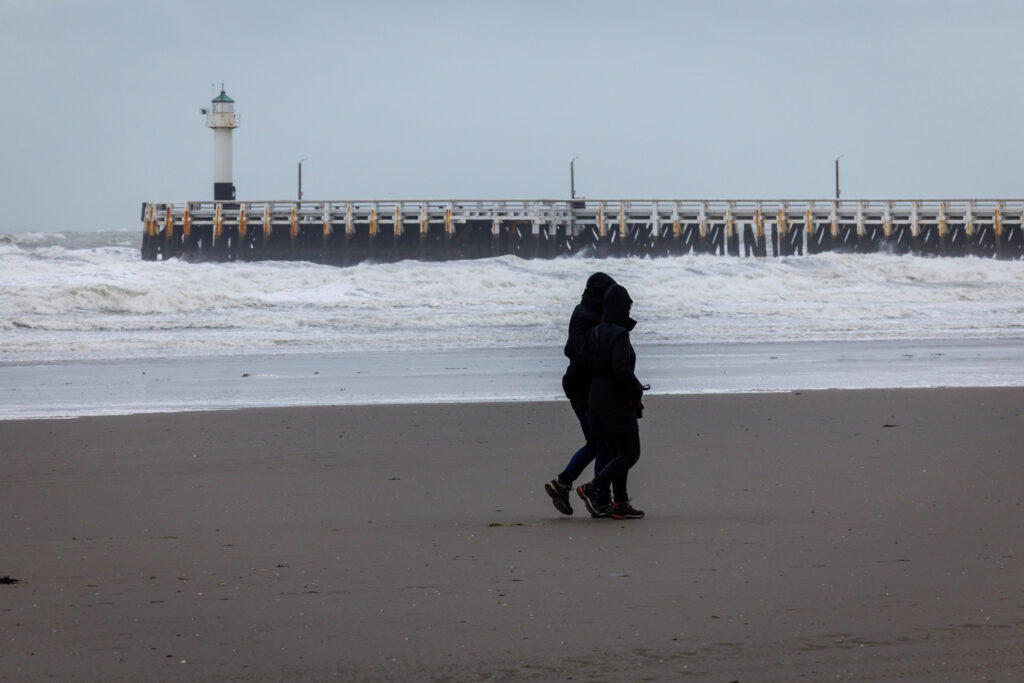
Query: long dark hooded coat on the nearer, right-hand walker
xmin=587 ymin=285 xmax=643 ymax=434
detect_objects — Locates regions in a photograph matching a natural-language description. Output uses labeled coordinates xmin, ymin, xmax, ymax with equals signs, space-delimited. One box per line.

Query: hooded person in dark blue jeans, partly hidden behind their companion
xmin=544 ymin=272 xmax=615 ymax=515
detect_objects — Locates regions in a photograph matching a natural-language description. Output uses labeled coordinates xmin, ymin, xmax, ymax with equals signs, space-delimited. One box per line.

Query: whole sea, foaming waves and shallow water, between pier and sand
xmin=0 ymin=230 xmax=1024 ymax=418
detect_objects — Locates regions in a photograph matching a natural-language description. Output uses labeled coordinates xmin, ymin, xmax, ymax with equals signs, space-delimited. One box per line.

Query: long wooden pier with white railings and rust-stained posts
xmin=141 ymin=199 xmax=1024 ymax=265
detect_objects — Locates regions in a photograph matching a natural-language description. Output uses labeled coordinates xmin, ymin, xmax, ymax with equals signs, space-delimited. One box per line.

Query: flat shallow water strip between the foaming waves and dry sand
xmin=6 ymin=339 xmax=1024 ymax=421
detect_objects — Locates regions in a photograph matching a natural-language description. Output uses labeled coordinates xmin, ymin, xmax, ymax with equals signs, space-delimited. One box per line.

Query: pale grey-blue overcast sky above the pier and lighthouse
xmin=0 ymin=0 xmax=1024 ymax=232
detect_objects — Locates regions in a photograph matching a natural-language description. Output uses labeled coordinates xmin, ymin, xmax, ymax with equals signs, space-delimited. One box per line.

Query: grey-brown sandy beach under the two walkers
xmin=0 ymin=388 xmax=1024 ymax=682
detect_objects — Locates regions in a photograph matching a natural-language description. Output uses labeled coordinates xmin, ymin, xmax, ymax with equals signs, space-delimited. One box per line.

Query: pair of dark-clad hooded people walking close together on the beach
xmin=544 ymin=272 xmax=649 ymax=519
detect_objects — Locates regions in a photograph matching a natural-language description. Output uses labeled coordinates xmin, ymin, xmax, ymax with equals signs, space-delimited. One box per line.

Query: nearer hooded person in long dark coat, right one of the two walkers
xmin=577 ymin=285 xmax=649 ymax=519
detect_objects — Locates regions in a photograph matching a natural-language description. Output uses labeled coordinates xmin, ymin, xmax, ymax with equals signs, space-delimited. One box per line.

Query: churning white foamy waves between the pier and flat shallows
xmin=0 ymin=231 xmax=1024 ymax=362
